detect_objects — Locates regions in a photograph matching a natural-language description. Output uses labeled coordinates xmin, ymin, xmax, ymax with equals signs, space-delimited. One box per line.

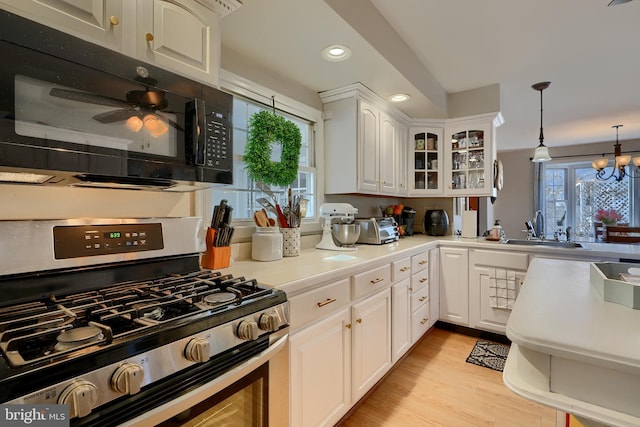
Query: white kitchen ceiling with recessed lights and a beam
xmin=222 ymin=0 xmax=640 ymax=155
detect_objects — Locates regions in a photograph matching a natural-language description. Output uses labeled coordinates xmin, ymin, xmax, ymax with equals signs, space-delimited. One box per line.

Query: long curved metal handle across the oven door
xmin=121 ymin=328 xmax=289 ymax=427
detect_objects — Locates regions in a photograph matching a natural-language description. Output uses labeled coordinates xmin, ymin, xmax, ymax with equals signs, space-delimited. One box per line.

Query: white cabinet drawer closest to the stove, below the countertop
xmin=289 ymin=279 xmax=349 ymax=329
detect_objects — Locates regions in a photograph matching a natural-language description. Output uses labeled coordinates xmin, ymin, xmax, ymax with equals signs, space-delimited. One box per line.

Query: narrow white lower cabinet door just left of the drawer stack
xmin=391 ymin=278 xmax=411 ymax=363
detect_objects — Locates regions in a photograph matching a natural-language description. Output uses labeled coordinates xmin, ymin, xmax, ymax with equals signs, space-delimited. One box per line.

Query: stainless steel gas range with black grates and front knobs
xmin=0 ymin=218 xmax=289 ymax=426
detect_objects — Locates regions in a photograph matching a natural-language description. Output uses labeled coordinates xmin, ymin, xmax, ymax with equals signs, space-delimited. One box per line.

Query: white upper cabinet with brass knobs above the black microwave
xmin=0 ymin=0 xmax=241 ymax=86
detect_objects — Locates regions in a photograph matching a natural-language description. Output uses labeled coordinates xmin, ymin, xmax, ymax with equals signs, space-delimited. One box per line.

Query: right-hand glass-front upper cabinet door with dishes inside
xmin=444 ymin=115 xmax=501 ymax=196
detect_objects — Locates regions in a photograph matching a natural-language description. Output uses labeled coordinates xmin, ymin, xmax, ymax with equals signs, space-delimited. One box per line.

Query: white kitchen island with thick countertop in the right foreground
xmin=504 ymin=258 xmax=640 ymax=426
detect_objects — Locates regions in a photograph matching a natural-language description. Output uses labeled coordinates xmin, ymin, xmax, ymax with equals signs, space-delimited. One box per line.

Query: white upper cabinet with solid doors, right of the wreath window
xmin=320 ymin=84 xmax=407 ymax=196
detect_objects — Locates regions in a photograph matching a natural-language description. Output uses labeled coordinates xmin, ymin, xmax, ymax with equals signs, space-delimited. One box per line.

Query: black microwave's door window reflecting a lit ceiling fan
xmin=15 ymin=74 xmax=178 ymax=157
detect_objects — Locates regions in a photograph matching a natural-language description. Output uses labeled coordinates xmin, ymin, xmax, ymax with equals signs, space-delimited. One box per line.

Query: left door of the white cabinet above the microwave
xmin=0 ymin=0 xmax=124 ymax=51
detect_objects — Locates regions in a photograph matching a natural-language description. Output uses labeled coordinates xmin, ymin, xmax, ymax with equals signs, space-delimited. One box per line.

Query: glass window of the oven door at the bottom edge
xmin=159 ymin=363 xmax=269 ymax=427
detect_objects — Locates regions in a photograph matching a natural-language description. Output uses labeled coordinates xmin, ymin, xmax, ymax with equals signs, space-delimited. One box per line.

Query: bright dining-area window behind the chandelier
xmin=540 ymin=160 xmax=640 ymax=240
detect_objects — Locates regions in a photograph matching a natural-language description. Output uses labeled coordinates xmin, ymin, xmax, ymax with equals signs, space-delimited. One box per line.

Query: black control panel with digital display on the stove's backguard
xmin=53 ymin=223 xmax=164 ymax=259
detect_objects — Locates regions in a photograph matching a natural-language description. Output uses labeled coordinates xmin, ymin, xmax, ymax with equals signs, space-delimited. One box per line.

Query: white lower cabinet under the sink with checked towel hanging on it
xmin=469 ymin=250 xmax=529 ymax=334
